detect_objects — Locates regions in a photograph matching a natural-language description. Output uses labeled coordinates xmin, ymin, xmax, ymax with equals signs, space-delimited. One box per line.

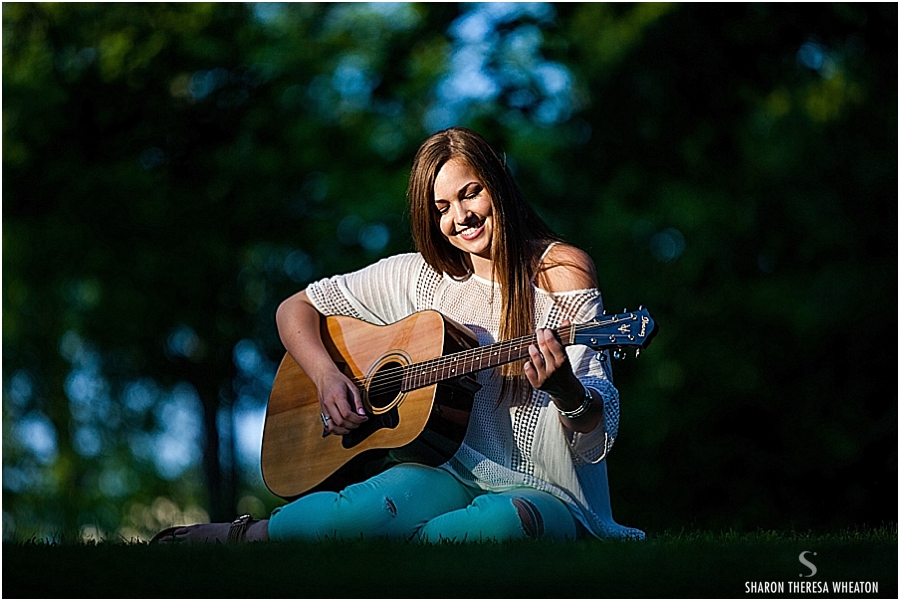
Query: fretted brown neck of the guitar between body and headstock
xmin=402 ymin=325 xmax=575 ymax=392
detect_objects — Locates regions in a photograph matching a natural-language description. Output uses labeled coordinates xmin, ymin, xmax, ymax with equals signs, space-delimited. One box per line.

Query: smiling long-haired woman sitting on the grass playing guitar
xmin=155 ymin=127 xmax=643 ymax=542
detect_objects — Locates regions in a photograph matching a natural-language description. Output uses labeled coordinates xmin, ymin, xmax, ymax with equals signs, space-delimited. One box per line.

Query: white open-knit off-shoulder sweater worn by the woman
xmin=307 ymin=253 xmax=643 ymax=538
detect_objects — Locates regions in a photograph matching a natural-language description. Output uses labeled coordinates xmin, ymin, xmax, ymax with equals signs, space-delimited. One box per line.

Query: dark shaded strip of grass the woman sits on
xmin=3 ymin=526 xmax=897 ymax=599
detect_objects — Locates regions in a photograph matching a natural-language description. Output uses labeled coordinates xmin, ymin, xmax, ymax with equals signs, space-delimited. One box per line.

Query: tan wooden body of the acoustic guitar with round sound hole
xmin=261 ymin=311 xmax=478 ymax=499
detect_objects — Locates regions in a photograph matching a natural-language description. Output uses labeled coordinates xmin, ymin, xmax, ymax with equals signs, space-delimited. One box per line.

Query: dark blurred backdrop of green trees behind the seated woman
xmin=2 ymin=3 xmax=898 ymax=541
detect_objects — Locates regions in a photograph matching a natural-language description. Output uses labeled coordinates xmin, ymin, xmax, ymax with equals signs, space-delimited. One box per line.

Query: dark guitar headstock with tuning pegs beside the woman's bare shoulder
xmin=572 ymin=307 xmax=659 ymax=359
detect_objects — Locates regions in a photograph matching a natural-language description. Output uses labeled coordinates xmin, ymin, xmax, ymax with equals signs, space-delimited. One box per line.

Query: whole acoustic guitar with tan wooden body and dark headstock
xmin=261 ymin=308 xmax=657 ymax=499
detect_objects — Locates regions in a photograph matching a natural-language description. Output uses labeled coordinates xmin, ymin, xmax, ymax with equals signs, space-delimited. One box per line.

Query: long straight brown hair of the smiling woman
xmin=407 ymin=127 xmax=560 ymax=392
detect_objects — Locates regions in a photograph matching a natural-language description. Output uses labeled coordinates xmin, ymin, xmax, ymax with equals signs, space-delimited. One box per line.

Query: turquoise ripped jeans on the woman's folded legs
xmin=269 ymin=463 xmax=578 ymax=542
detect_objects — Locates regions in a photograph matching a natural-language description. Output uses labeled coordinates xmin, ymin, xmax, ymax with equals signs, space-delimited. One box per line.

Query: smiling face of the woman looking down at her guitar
xmin=434 ymin=159 xmax=494 ymax=279
